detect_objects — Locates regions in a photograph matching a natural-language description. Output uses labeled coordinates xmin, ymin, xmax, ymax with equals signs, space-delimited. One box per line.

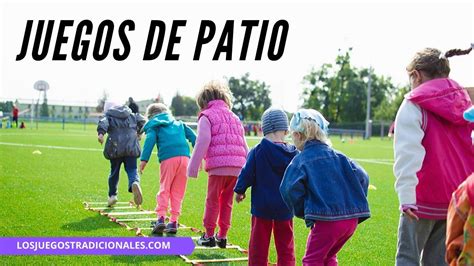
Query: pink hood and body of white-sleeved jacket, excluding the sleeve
xmin=408 ymin=78 xmax=474 ymax=219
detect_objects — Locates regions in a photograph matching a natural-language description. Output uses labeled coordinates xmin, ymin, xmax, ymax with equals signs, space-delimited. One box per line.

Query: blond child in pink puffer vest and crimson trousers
xmin=188 ymin=81 xmax=248 ymax=248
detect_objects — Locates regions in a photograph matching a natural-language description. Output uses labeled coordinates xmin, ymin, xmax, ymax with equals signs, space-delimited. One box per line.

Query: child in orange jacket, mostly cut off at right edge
xmin=446 ymin=107 xmax=474 ymax=265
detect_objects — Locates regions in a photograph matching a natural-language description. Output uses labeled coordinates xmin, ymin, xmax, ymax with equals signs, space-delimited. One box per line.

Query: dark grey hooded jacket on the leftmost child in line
xmin=97 ymin=106 xmax=145 ymax=160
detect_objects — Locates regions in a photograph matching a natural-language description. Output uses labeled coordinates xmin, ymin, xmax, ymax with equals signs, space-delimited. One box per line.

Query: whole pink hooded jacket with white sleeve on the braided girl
xmin=394 ymin=78 xmax=474 ymax=220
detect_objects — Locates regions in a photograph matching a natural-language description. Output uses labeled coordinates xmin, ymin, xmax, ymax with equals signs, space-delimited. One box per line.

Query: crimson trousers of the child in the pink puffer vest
xmin=203 ymin=175 xmax=237 ymax=238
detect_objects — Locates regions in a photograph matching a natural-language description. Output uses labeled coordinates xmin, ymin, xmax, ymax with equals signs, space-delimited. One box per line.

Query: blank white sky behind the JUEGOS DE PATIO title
xmin=0 ymin=1 xmax=474 ymax=111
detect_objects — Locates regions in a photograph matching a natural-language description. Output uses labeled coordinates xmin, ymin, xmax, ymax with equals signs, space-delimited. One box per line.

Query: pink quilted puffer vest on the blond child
xmin=199 ymin=100 xmax=247 ymax=171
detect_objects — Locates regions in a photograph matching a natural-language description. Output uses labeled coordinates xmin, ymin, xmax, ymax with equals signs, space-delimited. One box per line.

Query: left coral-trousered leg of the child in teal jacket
xmin=155 ymin=157 xmax=176 ymax=218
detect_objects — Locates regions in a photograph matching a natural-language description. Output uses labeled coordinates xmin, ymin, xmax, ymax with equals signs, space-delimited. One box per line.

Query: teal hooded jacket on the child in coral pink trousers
xmin=140 ymin=113 xmax=196 ymax=163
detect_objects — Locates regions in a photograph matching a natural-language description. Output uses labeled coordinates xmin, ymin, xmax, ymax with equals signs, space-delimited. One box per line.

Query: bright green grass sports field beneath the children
xmin=0 ymin=124 xmax=399 ymax=265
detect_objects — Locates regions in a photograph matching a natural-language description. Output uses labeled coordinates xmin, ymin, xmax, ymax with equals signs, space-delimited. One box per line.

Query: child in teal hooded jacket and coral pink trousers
xmin=140 ymin=103 xmax=196 ymax=234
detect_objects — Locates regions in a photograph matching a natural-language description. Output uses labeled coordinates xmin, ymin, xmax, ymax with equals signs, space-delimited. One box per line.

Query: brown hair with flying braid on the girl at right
xmin=406 ymin=47 xmax=472 ymax=79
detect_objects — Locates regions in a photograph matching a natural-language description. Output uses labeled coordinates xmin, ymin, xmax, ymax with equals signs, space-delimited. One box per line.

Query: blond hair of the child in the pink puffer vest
xmin=196 ymin=80 xmax=232 ymax=110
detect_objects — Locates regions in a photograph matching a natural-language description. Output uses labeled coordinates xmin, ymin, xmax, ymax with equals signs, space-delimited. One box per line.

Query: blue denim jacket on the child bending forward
xmin=280 ymin=140 xmax=370 ymax=227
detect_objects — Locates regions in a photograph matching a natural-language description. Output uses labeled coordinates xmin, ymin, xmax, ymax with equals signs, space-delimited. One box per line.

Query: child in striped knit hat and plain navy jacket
xmin=234 ymin=109 xmax=298 ymax=265
